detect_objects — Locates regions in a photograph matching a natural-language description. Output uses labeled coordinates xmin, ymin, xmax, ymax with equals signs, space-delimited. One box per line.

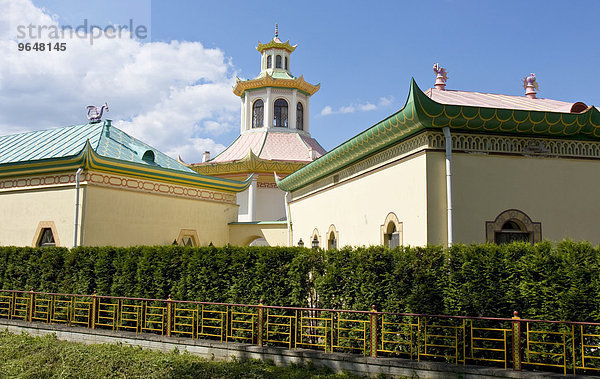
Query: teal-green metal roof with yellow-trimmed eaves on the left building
xmin=0 ymin=120 xmax=251 ymax=192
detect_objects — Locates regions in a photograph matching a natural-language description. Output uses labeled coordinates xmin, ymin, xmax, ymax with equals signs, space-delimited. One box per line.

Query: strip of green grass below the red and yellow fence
xmin=0 ymin=331 xmax=358 ymax=379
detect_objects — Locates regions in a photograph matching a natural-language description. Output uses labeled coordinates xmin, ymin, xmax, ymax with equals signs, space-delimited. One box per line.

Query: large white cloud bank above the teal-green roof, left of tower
xmin=0 ymin=0 xmax=239 ymax=162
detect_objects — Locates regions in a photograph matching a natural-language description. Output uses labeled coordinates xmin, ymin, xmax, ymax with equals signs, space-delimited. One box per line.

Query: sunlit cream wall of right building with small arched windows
xmin=290 ymin=153 xmax=428 ymax=247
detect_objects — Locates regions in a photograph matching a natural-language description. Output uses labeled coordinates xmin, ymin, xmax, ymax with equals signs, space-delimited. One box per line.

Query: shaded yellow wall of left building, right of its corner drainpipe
xmin=82 ymin=186 xmax=237 ymax=246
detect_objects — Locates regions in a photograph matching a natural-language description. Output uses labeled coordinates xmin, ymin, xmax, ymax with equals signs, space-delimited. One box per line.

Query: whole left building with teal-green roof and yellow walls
xmin=0 ymin=120 xmax=250 ymax=247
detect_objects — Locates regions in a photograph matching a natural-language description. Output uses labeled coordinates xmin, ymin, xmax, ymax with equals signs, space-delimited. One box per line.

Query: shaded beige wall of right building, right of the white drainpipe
xmin=453 ymin=153 xmax=600 ymax=244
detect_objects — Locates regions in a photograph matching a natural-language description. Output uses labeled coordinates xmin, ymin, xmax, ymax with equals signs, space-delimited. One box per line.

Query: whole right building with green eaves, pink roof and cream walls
xmin=278 ymin=76 xmax=600 ymax=248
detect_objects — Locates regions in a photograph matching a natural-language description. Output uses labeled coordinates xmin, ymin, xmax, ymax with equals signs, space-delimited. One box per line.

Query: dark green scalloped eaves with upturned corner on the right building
xmin=277 ymin=79 xmax=600 ymax=191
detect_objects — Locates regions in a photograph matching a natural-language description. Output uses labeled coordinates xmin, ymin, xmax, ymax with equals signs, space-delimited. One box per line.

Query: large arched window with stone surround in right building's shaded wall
xmin=485 ymin=209 xmax=542 ymax=244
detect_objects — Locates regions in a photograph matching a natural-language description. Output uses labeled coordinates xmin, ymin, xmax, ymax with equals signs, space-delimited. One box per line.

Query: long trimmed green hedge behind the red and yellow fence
xmin=0 ymin=241 xmax=600 ymax=321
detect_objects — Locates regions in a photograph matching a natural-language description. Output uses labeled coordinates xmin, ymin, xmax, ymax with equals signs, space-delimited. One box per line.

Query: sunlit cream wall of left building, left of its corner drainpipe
xmin=0 ymin=186 xmax=75 ymax=247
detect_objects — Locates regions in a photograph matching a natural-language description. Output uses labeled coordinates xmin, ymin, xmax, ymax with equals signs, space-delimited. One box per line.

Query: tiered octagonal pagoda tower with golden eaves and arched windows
xmin=189 ymin=26 xmax=325 ymax=229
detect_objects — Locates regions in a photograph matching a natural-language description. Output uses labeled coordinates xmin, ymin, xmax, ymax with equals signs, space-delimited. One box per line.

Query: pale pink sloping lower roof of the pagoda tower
xmin=210 ymin=131 xmax=325 ymax=162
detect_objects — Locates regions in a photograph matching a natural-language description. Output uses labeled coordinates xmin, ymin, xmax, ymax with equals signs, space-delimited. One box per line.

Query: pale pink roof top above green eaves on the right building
xmin=425 ymin=88 xmax=587 ymax=113
